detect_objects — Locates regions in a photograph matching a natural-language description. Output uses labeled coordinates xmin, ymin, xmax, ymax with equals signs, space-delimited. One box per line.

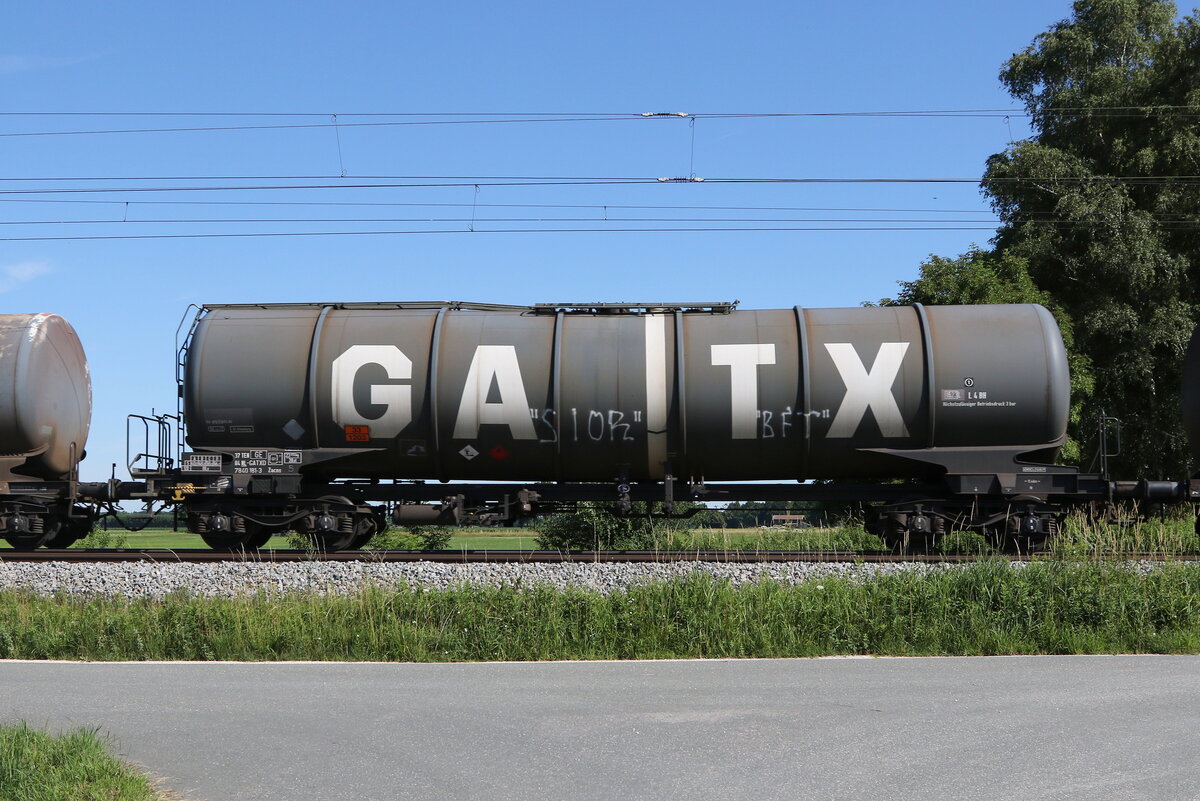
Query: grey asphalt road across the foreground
xmin=0 ymin=656 xmax=1200 ymax=801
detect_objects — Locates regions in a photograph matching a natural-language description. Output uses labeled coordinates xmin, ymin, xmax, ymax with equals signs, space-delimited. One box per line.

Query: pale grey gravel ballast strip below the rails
xmin=0 ymin=561 xmax=974 ymax=598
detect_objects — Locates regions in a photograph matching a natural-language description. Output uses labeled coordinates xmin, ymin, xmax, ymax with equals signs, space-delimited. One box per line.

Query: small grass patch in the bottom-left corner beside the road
xmin=0 ymin=723 xmax=163 ymax=801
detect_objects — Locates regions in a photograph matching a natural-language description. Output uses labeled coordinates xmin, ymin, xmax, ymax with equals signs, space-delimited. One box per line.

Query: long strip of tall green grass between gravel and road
xmin=0 ymin=560 xmax=1200 ymax=662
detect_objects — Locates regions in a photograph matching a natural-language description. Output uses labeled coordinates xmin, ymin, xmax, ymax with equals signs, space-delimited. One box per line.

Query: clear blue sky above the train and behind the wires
xmin=0 ymin=0 xmax=1070 ymax=478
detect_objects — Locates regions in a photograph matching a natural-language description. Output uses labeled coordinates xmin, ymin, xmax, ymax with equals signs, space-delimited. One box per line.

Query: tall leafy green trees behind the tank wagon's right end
xmin=883 ymin=0 xmax=1200 ymax=477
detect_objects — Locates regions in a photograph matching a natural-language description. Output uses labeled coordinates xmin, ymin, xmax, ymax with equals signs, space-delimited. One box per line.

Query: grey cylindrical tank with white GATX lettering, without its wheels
xmin=184 ymin=303 xmax=1070 ymax=482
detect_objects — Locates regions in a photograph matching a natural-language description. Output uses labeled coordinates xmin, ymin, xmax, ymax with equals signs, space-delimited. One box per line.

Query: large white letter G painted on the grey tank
xmin=332 ymin=345 xmax=413 ymax=439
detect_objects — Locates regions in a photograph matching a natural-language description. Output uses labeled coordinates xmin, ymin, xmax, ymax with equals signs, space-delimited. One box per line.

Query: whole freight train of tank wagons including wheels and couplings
xmin=0 ymin=302 xmax=1200 ymax=552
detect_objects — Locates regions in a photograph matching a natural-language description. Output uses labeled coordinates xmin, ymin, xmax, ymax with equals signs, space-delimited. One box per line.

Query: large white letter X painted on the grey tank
xmin=826 ymin=342 xmax=908 ymax=438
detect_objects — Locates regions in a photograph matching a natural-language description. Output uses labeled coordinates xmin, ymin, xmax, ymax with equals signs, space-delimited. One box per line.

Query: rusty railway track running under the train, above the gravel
xmin=0 ymin=548 xmax=1200 ymax=565
